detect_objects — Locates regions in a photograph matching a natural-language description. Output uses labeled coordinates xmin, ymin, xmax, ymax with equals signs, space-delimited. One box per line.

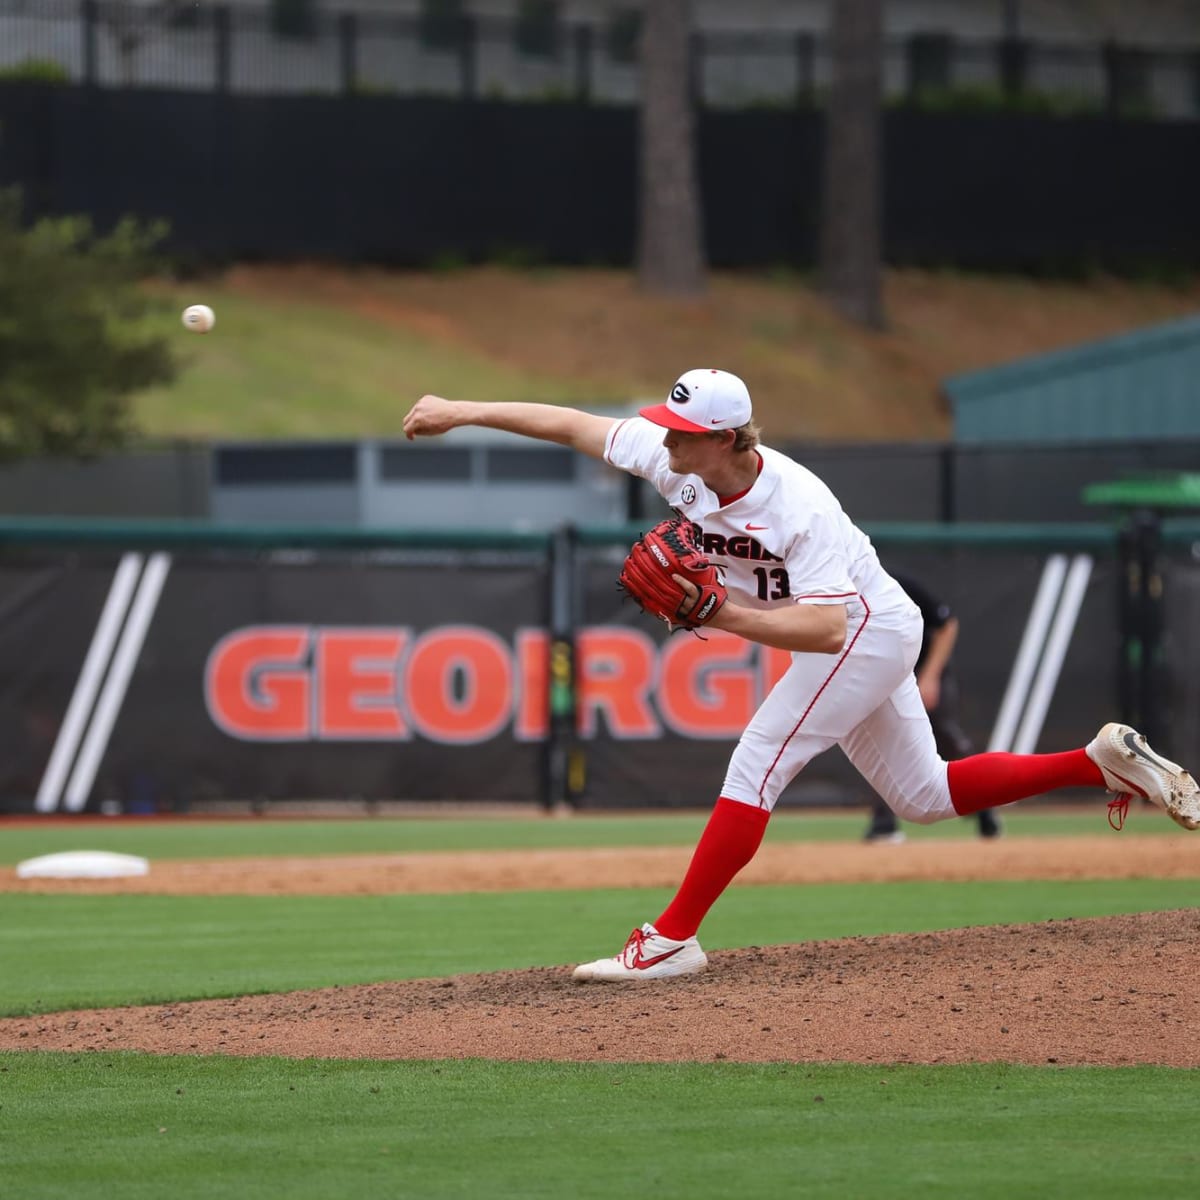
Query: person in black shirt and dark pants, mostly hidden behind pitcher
xmin=864 ymin=570 xmax=1000 ymax=842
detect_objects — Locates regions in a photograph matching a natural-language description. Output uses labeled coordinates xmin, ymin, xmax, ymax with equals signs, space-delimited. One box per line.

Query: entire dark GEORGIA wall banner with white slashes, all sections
xmin=0 ymin=546 xmax=1200 ymax=812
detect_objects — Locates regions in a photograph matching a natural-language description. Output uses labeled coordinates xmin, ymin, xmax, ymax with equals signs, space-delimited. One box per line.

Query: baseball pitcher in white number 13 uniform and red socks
xmin=404 ymin=368 xmax=1200 ymax=983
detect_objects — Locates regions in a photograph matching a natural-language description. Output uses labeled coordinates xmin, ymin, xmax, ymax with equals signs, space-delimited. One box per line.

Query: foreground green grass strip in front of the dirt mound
xmin=0 ymin=1054 xmax=1200 ymax=1200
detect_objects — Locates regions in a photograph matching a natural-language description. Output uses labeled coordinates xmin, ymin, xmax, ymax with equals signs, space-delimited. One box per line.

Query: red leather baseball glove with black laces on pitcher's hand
xmin=617 ymin=517 xmax=727 ymax=631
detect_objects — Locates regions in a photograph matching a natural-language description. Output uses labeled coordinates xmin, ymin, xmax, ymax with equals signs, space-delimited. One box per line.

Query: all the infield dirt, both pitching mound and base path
xmin=0 ymin=834 xmax=1200 ymax=1067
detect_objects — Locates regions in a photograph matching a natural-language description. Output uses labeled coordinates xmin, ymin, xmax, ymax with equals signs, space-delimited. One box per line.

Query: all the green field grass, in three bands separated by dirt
xmin=0 ymin=811 xmax=1200 ymax=1200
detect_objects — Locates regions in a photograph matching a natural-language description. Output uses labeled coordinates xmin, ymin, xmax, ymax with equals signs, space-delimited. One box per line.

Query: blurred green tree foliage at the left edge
xmin=0 ymin=191 xmax=176 ymax=458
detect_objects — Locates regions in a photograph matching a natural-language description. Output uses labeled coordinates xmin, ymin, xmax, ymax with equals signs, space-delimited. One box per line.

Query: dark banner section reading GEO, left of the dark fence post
xmin=0 ymin=552 xmax=547 ymax=811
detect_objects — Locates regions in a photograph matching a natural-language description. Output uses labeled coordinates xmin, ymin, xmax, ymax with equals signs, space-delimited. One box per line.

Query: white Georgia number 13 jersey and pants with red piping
xmin=605 ymin=416 xmax=958 ymax=823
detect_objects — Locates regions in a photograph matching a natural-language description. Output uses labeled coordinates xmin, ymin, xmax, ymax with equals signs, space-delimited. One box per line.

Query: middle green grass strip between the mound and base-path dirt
xmin=0 ymin=880 xmax=1195 ymax=1015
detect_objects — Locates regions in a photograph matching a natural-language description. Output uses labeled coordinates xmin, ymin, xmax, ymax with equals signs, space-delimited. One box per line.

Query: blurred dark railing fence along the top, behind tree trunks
xmin=0 ymin=0 xmax=1200 ymax=120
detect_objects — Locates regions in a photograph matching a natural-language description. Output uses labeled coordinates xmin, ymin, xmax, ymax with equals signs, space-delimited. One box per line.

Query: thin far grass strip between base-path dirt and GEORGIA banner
xmin=0 ymin=803 xmax=1161 ymax=865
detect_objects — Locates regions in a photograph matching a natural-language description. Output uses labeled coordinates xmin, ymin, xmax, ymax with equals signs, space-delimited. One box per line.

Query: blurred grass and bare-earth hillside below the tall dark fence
xmin=134 ymin=265 xmax=1200 ymax=440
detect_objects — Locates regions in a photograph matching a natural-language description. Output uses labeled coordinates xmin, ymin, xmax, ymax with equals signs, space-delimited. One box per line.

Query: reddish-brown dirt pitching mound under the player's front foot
xmin=0 ymin=910 xmax=1200 ymax=1067
